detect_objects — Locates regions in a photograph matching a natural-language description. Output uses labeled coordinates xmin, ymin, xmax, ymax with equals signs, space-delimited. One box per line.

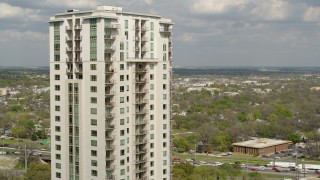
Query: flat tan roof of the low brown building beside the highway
xmin=232 ymin=138 xmax=291 ymax=149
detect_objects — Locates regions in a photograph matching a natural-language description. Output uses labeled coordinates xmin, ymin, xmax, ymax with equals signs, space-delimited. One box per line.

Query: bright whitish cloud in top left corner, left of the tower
xmin=0 ymin=3 xmax=40 ymax=20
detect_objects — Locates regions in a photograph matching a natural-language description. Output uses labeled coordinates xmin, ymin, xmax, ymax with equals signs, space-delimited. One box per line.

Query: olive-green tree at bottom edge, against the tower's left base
xmin=25 ymin=163 xmax=51 ymax=180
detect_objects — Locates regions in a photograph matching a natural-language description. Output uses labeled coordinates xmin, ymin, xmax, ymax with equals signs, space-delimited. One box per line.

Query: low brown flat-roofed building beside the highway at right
xmin=232 ymin=138 xmax=292 ymax=155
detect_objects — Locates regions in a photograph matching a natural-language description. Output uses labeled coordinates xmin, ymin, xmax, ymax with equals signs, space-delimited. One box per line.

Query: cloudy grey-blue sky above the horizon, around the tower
xmin=0 ymin=0 xmax=320 ymax=67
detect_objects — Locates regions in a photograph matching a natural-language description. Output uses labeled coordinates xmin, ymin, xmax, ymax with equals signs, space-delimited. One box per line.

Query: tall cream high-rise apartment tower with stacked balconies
xmin=49 ymin=6 xmax=173 ymax=180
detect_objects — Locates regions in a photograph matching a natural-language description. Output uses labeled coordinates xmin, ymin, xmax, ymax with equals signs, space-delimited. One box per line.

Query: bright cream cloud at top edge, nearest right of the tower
xmin=191 ymin=0 xmax=250 ymax=14
